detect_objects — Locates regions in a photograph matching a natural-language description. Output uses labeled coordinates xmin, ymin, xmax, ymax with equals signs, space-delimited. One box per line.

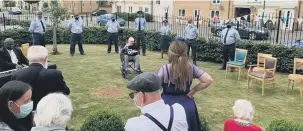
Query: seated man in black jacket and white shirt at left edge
xmin=0 ymin=38 xmax=28 ymax=72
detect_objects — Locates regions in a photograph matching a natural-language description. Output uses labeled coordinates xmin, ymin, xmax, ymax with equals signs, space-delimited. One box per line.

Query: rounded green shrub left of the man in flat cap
xmin=81 ymin=110 xmax=124 ymax=131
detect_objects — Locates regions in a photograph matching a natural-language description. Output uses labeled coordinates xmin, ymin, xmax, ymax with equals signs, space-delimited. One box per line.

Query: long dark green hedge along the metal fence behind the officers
xmin=0 ymin=26 xmax=303 ymax=73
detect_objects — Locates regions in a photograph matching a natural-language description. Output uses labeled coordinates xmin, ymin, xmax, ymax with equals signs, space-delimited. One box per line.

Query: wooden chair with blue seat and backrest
xmin=225 ymin=48 xmax=247 ymax=80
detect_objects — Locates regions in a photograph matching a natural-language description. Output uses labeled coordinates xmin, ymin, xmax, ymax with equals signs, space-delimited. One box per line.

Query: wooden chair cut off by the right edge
xmin=286 ymin=58 xmax=303 ymax=97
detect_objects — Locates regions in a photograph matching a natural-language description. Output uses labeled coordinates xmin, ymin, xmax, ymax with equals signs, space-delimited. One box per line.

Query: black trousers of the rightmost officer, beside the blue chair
xmin=222 ymin=44 xmax=236 ymax=69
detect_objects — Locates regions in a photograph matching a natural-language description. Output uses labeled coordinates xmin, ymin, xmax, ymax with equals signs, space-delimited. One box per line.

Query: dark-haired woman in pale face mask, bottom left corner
xmin=0 ymin=81 xmax=33 ymax=131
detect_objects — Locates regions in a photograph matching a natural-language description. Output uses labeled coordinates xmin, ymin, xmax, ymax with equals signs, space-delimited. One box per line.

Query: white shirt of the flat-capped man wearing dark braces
xmin=124 ymin=99 xmax=188 ymax=131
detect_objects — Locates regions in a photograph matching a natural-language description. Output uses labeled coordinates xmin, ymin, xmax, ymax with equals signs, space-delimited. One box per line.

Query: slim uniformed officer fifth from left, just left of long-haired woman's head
xmin=160 ymin=20 xmax=171 ymax=58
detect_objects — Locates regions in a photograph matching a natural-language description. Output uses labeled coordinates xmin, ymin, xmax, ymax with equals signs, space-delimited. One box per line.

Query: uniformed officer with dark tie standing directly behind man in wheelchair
xmin=135 ymin=11 xmax=146 ymax=56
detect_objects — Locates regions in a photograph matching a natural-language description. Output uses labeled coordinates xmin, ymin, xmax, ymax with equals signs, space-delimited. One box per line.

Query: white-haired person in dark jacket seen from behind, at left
xmin=12 ymin=46 xmax=70 ymax=110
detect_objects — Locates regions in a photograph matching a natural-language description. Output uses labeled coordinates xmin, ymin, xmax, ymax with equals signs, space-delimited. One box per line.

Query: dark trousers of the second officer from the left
xmin=70 ymin=33 xmax=84 ymax=55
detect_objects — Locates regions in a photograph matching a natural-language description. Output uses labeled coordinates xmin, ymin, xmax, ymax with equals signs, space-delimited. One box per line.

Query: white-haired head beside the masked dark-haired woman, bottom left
xmin=34 ymin=93 xmax=73 ymax=127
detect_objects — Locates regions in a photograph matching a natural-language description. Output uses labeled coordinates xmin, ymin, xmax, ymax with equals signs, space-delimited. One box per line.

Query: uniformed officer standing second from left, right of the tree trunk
xmin=68 ymin=15 xmax=85 ymax=56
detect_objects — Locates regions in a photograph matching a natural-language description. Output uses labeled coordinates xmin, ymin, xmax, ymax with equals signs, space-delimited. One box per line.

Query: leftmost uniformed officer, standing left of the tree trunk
xmin=29 ymin=11 xmax=46 ymax=46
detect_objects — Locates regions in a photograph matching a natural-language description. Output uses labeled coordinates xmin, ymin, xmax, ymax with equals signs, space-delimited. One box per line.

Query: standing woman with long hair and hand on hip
xmin=158 ymin=41 xmax=213 ymax=131
